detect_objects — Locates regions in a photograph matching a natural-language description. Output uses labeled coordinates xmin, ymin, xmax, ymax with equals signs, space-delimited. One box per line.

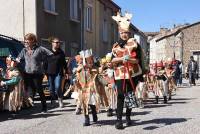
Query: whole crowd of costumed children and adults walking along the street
xmin=0 ymin=13 xmax=198 ymax=129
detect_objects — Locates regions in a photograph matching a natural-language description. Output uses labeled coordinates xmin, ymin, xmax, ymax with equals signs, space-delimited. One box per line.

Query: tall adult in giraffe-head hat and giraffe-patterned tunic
xmin=112 ymin=13 xmax=146 ymax=129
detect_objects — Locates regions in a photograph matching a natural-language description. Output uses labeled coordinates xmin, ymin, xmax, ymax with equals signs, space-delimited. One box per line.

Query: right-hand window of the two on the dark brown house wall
xmin=70 ymin=0 xmax=79 ymax=20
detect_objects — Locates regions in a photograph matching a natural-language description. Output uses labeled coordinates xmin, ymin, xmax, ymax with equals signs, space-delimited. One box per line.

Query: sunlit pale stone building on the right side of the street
xmin=150 ymin=22 xmax=200 ymax=73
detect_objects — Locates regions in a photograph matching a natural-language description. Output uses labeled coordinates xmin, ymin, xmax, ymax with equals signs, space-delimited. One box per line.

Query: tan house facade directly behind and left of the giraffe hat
xmin=84 ymin=0 xmax=120 ymax=57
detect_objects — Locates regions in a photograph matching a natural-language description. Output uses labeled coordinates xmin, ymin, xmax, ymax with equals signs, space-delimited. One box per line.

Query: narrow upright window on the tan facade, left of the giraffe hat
xmin=85 ymin=6 xmax=92 ymax=31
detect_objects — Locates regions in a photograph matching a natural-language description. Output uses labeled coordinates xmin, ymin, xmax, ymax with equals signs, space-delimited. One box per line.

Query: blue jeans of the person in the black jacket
xmin=48 ymin=74 xmax=63 ymax=100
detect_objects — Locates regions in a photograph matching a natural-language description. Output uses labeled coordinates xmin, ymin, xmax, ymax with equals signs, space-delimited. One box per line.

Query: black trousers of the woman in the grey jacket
xmin=24 ymin=73 xmax=47 ymax=108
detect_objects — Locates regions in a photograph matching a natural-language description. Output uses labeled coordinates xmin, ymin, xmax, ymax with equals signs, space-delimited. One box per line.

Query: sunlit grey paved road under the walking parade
xmin=0 ymin=80 xmax=200 ymax=134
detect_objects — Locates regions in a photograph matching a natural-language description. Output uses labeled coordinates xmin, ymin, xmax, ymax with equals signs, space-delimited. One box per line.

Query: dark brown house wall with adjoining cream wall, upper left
xmin=0 ymin=0 xmax=84 ymax=56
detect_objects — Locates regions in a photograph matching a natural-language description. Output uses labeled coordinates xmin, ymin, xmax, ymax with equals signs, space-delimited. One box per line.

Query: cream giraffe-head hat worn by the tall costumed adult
xmin=112 ymin=12 xmax=133 ymax=32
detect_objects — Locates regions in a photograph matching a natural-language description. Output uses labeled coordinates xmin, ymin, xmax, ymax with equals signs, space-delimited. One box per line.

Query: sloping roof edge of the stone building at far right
xmin=156 ymin=21 xmax=200 ymax=42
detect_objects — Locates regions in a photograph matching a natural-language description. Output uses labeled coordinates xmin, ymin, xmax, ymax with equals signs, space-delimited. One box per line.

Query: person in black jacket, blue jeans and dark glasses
xmin=46 ymin=38 xmax=67 ymax=108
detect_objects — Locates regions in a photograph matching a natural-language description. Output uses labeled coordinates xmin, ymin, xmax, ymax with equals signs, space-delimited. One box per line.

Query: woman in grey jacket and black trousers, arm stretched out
xmin=17 ymin=33 xmax=53 ymax=112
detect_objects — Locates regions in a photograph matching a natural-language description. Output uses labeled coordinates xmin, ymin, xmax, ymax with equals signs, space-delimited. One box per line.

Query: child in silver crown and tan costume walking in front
xmin=77 ymin=49 xmax=98 ymax=126
